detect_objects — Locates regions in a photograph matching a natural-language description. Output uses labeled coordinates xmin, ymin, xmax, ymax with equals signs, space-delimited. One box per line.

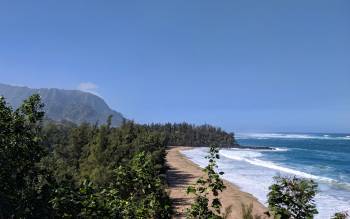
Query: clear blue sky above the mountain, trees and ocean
xmin=0 ymin=0 xmax=350 ymax=132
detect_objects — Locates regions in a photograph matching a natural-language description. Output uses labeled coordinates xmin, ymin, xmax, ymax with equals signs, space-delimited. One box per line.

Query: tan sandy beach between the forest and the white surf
xmin=166 ymin=146 xmax=267 ymax=219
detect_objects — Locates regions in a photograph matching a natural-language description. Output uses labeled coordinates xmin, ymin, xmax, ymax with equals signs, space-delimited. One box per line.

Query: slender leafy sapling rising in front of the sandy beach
xmin=186 ymin=145 xmax=225 ymax=219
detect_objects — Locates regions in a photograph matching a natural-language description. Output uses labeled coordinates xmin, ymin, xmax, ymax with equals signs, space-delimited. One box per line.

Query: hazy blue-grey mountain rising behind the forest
xmin=0 ymin=83 xmax=124 ymax=126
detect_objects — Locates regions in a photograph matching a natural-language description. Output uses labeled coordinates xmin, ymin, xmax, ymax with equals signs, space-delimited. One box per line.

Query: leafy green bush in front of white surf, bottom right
xmin=268 ymin=176 xmax=318 ymax=219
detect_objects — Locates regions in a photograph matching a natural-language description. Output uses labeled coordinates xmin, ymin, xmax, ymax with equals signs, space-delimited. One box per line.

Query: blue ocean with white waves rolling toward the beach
xmin=182 ymin=133 xmax=350 ymax=219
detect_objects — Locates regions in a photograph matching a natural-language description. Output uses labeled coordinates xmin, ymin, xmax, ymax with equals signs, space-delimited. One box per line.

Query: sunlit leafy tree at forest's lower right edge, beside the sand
xmin=113 ymin=152 xmax=172 ymax=218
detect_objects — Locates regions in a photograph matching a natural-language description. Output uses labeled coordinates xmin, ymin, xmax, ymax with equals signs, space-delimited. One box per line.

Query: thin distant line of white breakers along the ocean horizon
xmin=236 ymin=133 xmax=350 ymax=140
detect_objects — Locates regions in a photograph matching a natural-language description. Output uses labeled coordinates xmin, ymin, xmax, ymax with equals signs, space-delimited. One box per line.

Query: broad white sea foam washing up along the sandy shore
xmin=183 ymin=148 xmax=350 ymax=219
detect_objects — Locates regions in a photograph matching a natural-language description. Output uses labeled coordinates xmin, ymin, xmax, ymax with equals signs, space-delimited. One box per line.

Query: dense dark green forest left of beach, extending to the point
xmin=0 ymin=95 xmax=234 ymax=218
